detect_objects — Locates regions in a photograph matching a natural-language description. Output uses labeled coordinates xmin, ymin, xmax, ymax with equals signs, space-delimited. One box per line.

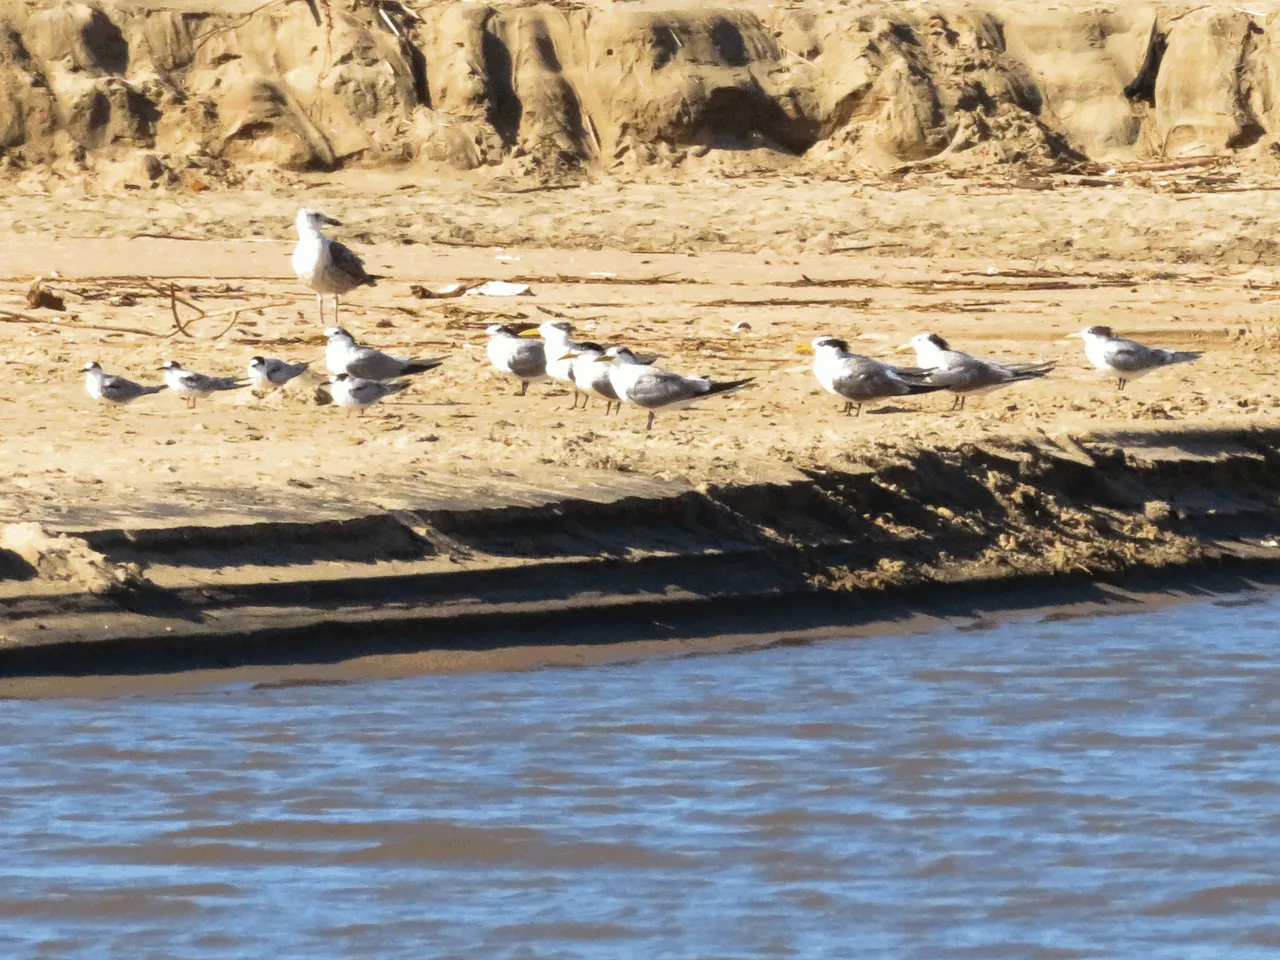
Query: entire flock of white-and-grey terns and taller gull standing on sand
xmin=83 ymin=209 xmax=1201 ymax=430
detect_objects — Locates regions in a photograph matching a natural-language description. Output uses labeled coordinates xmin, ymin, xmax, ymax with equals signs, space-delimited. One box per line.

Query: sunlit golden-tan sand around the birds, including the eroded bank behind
xmin=0 ymin=0 xmax=1280 ymax=691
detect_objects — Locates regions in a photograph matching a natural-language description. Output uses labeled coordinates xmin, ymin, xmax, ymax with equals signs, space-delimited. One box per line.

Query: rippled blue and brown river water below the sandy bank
xmin=0 ymin=596 xmax=1280 ymax=960
